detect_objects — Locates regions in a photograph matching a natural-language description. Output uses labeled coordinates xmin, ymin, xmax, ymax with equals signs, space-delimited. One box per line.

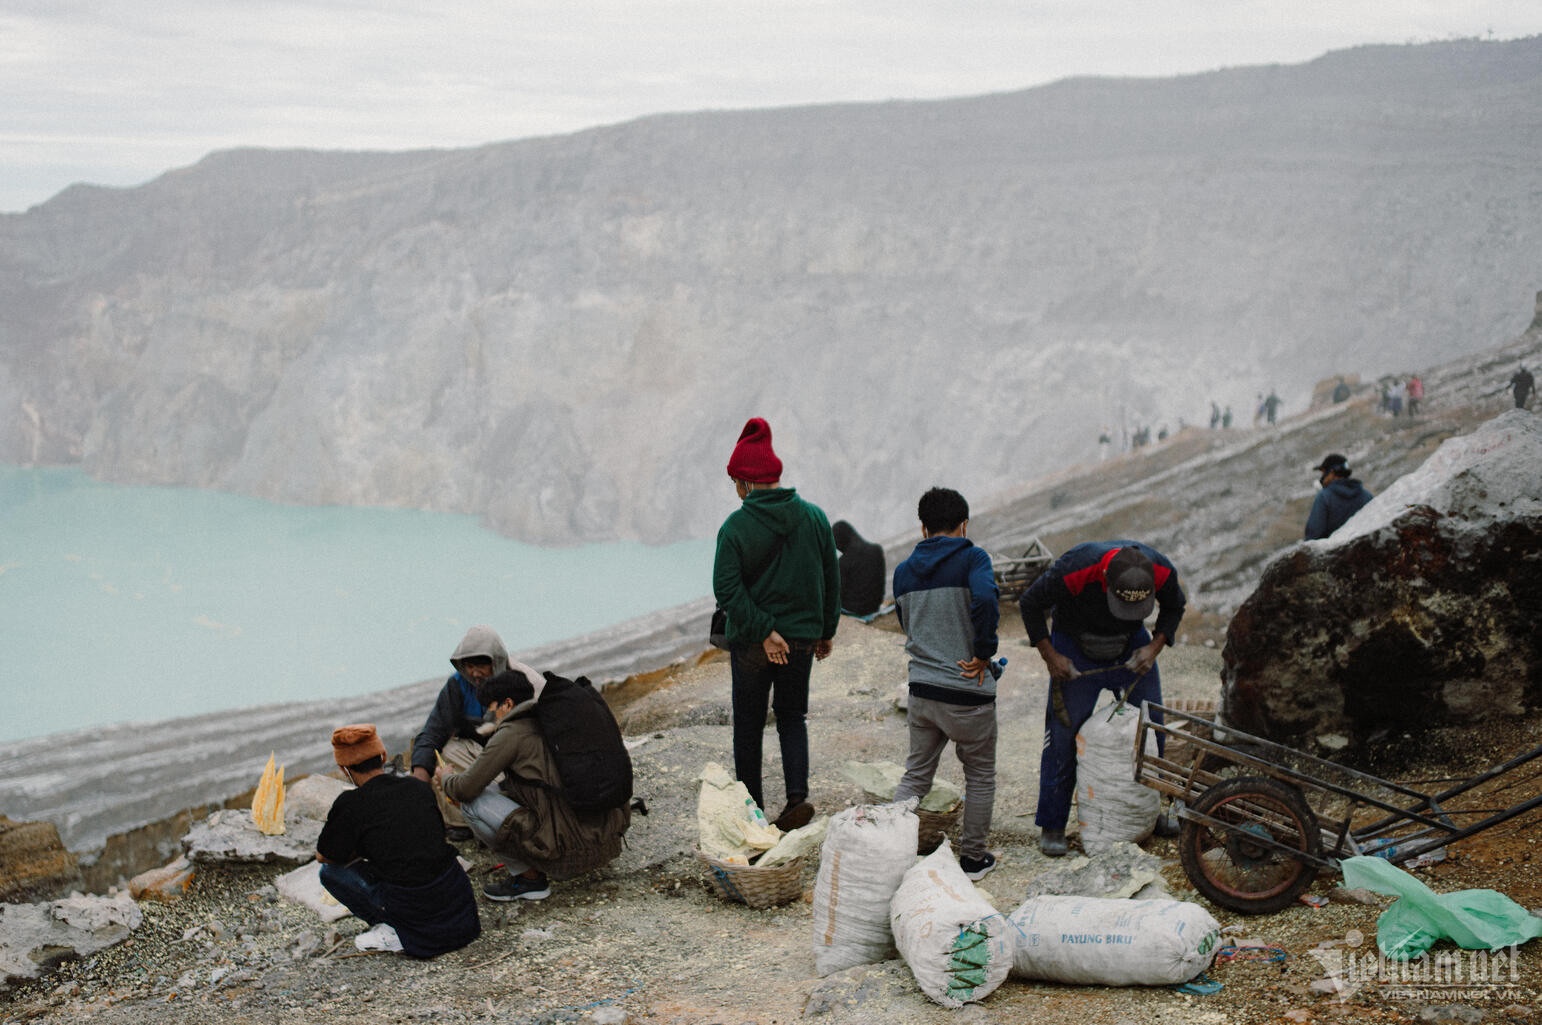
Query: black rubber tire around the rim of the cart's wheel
xmin=1178 ymin=775 xmax=1321 ymax=914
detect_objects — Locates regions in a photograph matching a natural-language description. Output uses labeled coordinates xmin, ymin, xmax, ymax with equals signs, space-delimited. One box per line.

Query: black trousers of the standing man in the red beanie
xmin=728 ymin=641 xmax=814 ymax=817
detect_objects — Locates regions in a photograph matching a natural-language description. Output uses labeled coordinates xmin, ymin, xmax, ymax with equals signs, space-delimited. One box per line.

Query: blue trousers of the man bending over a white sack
xmin=1033 ymin=627 xmax=1161 ymax=829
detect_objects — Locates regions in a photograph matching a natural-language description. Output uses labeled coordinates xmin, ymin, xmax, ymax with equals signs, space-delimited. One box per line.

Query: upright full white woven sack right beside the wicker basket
xmin=814 ymin=798 xmax=921 ymax=976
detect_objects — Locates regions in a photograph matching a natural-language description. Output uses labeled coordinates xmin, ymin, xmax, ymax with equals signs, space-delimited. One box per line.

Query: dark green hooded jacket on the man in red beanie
xmin=712 ymin=487 xmax=840 ymax=644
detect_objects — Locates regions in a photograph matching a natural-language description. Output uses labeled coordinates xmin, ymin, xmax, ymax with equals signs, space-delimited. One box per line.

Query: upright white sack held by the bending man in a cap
xmin=1076 ymin=695 xmax=1161 ymax=854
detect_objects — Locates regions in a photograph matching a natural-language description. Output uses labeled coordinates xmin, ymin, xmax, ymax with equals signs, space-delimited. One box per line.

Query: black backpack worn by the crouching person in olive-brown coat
xmin=535 ymin=672 xmax=632 ymax=812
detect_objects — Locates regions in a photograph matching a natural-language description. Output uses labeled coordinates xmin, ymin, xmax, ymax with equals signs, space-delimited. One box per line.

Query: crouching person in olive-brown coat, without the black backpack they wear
xmin=435 ymin=669 xmax=632 ymax=900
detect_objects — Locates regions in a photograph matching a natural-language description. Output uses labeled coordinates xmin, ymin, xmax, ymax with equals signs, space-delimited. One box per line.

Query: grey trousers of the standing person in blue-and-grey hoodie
xmin=894 ymin=694 xmax=996 ymax=859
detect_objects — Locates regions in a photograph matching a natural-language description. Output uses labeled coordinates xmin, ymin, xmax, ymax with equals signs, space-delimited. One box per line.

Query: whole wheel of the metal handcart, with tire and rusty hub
xmin=1178 ymin=775 xmax=1321 ymax=914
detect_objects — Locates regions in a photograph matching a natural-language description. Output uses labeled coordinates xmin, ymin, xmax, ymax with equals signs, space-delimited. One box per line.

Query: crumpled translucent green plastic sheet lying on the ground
xmin=1340 ymin=855 xmax=1542 ymax=960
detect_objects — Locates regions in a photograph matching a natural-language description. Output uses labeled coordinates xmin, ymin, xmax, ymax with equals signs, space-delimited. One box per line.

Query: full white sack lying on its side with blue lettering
xmin=1012 ymin=896 xmax=1221 ymax=986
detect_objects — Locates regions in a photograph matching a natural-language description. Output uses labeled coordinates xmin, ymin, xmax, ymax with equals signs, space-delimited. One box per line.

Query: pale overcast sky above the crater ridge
xmin=0 ymin=0 xmax=1542 ymax=211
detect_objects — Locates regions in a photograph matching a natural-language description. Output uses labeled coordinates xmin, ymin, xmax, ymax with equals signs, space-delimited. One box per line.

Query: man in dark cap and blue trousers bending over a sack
xmin=1018 ymin=541 xmax=1186 ymax=857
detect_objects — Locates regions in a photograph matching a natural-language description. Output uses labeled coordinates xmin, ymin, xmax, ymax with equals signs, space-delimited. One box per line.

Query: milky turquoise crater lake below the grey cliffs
xmin=0 ymin=465 xmax=712 ymax=741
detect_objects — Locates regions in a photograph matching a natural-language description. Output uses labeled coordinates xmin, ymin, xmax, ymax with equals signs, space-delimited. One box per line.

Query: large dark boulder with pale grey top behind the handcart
xmin=1221 ymin=410 xmax=1542 ymax=749
